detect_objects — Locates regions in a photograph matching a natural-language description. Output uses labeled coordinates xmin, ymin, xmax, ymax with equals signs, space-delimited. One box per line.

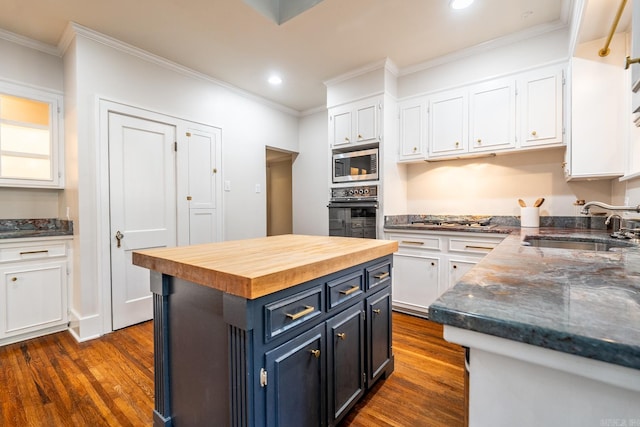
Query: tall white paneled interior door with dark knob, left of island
xmin=109 ymin=112 xmax=176 ymax=330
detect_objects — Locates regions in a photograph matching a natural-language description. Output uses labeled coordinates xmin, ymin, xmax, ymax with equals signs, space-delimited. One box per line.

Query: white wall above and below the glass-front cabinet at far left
xmin=0 ymin=38 xmax=63 ymax=219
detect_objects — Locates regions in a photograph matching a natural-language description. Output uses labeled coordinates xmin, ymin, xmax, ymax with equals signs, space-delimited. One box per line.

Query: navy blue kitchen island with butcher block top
xmin=133 ymin=235 xmax=397 ymax=427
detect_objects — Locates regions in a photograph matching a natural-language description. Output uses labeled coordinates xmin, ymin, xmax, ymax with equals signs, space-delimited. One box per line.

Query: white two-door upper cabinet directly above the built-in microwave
xmin=329 ymin=97 xmax=382 ymax=148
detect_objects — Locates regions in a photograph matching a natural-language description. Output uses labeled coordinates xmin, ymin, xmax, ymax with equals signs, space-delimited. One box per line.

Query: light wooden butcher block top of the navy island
xmin=133 ymin=234 xmax=398 ymax=299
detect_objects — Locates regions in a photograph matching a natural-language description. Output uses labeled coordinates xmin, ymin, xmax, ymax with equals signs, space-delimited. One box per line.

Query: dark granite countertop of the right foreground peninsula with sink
xmin=429 ymin=228 xmax=640 ymax=369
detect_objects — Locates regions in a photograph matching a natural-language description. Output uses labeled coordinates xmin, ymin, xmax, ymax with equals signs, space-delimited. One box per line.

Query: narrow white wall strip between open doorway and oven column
xmin=293 ymin=110 xmax=331 ymax=236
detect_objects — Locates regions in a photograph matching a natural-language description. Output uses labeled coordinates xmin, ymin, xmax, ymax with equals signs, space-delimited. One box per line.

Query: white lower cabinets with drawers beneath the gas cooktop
xmin=386 ymin=230 xmax=506 ymax=316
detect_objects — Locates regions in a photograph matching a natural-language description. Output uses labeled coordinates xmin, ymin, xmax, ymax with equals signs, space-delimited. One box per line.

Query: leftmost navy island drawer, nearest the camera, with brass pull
xmin=264 ymin=286 xmax=322 ymax=341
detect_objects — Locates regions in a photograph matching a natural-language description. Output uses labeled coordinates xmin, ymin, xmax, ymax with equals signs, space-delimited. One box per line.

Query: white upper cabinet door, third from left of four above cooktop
xmin=469 ymin=78 xmax=516 ymax=152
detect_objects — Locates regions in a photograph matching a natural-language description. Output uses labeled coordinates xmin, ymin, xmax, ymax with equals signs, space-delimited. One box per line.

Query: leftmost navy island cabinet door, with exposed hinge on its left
xmin=265 ymin=323 xmax=326 ymax=427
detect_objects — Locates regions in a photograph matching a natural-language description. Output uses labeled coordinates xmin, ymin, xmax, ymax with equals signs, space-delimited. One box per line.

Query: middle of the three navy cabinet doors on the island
xmin=327 ymin=302 xmax=366 ymax=425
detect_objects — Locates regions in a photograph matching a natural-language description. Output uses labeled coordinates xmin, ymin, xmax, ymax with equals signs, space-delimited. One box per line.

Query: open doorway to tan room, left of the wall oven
xmin=266 ymin=147 xmax=294 ymax=236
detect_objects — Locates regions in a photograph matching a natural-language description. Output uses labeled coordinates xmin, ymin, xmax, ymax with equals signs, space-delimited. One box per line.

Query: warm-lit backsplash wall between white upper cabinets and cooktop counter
xmin=407 ymin=148 xmax=611 ymax=216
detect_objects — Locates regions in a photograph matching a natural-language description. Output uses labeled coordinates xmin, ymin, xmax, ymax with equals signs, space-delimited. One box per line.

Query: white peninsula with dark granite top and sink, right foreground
xmin=429 ymin=228 xmax=640 ymax=427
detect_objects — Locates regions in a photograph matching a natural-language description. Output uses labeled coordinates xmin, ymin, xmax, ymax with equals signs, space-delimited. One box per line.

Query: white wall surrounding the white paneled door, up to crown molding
xmin=61 ymin=28 xmax=298 ymax=338
